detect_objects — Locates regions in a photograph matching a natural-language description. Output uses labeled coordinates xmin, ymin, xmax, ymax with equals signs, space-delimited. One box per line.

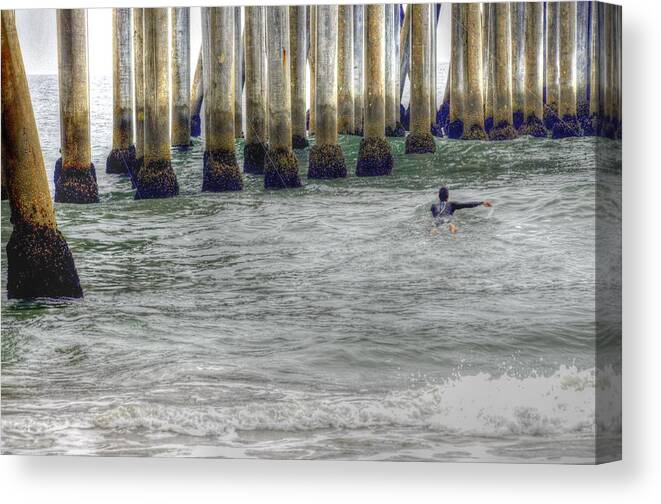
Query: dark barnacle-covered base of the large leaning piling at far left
xmin=7 ymin=223 xmax=83 ymax=299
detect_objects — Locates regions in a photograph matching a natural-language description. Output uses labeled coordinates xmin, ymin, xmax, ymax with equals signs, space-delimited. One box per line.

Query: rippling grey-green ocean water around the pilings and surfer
xmin=1 ymin=76 xmax=621 ymax=463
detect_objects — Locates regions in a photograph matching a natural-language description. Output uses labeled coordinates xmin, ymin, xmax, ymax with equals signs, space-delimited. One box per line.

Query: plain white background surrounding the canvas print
xmin=0 ymin=0 xmax=661 ymax=504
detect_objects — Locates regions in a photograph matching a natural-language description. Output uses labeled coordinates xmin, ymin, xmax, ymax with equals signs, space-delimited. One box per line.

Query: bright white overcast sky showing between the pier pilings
xmin=16 ymin=4 xmax=450 ymax=75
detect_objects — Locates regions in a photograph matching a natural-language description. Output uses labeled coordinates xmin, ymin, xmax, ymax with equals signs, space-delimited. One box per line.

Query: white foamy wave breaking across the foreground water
xmin=93 ymin=367 xmax=621 ymax=438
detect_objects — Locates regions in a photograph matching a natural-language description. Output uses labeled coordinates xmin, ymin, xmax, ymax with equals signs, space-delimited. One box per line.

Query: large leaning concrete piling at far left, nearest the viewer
xmin=0 ymin=10 xmax=83 ymax=299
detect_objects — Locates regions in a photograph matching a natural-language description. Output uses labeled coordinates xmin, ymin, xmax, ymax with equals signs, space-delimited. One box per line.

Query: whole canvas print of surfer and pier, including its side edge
xmin=0 ymin=1 xmax=623 ymax=464
